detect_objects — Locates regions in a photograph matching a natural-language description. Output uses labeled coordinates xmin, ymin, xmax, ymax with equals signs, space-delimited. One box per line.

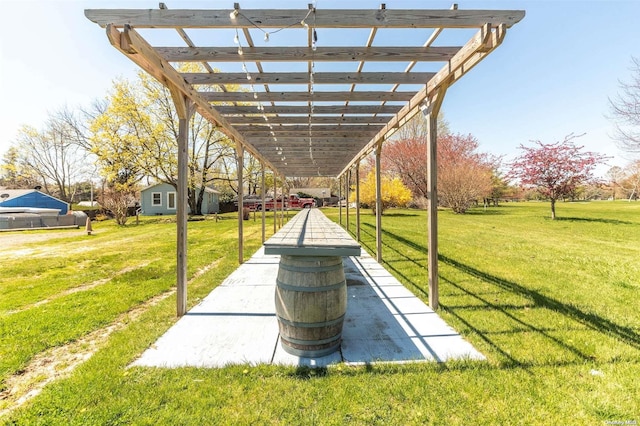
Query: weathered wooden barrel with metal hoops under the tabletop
xmin=275 ymin=255 xmax=347 ymax=358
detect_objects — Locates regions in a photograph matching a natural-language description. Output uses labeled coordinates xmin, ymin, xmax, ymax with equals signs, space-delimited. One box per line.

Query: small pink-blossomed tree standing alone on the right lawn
xmin=509 ymin=133 xmax=609 ymax=219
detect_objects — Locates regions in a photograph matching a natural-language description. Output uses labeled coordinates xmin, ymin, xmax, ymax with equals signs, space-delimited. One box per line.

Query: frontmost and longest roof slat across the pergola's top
xmin=85 ymin=9 xmax=524 ymax=29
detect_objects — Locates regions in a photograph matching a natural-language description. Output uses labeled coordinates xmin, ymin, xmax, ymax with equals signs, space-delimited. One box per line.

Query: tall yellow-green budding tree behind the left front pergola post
xmin=91 ymin=64 xmax=235 ymax=214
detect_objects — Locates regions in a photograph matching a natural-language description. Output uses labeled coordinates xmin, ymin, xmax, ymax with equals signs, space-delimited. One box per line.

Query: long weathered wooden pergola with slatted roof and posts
xmin=85 ymin=3 xmax=524 ymax=315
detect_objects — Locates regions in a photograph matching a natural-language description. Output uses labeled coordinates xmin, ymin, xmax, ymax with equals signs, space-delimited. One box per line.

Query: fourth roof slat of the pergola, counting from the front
xmin=204 ymin=91 xmax=413 ymax=103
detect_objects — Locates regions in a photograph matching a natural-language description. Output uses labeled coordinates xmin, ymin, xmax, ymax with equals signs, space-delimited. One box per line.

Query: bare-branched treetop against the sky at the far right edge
xmin=609 ymin=57 xmax=640 ymax=153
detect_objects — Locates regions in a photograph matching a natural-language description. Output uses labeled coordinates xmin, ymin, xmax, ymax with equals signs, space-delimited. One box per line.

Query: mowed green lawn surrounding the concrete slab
xmin=0 ymin=202 xmax=640 ymax=424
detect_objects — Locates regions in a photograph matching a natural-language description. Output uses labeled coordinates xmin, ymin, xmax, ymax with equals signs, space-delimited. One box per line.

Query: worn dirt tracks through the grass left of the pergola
xmin=0 ymin=259 xmax=220 ymax=417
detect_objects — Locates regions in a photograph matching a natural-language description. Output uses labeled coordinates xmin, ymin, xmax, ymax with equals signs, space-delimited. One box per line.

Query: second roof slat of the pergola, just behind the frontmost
xmin=155 ymin=46 xmax=460 ymax=62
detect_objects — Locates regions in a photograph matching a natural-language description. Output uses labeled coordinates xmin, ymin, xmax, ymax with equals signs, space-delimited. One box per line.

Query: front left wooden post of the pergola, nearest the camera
xmin=171 ymin=89 xmax=193 ymax=317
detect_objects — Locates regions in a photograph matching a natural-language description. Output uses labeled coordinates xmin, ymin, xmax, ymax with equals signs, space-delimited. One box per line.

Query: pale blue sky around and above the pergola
xmin=0 ymin=0 xmax=640 ymax=173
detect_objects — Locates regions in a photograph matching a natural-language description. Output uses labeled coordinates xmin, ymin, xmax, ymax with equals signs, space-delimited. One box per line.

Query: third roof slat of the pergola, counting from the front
xmin=182 ymin=72 xmax=435 ymax=84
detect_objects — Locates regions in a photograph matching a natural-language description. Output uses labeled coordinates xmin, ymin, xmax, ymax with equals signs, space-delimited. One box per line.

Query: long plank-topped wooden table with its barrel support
xmin=264 ymin=209 xmax=361 ymax=358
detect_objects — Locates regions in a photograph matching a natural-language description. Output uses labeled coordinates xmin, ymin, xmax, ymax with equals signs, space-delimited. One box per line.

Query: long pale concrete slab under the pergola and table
xmin=133 ymin=249 xmax=485 ymax=368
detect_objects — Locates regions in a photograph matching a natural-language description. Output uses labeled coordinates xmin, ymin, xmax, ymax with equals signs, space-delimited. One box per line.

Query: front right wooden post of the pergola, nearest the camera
xmin=422 ymin=87 xmax=446 ymax=311
